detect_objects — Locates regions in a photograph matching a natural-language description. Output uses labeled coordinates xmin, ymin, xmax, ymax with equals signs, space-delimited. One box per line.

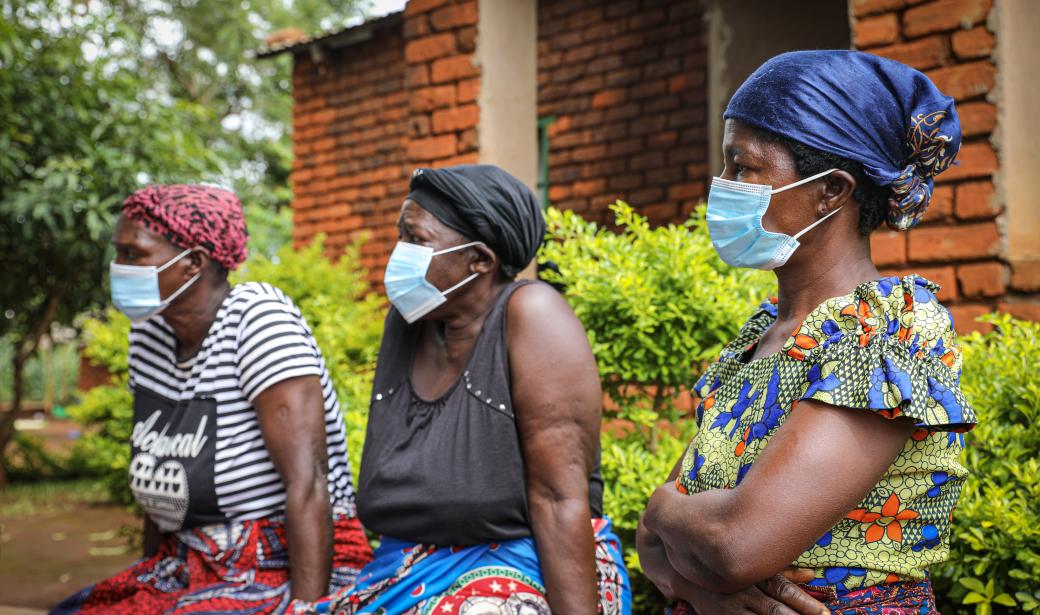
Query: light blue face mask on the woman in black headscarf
xmin=383 ymin=241 xmax=483 ymax=324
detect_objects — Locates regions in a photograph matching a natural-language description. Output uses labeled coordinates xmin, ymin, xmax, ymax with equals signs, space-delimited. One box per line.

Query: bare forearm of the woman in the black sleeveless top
xmin=530 ymin=496 xmax=599 ymax=615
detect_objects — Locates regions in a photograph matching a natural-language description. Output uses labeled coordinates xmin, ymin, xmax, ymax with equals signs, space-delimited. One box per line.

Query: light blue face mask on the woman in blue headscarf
xmin=705 ymin=169 xmax=841 ymax=270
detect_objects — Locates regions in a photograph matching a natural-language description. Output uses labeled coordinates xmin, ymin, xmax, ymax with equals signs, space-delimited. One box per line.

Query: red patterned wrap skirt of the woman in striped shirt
xmin=51 ymin=513 xmax=372 ymax=615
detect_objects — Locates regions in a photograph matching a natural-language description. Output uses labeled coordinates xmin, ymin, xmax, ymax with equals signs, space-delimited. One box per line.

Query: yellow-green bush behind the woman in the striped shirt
xmin=69 ymin=238 xmax=384 ymax=504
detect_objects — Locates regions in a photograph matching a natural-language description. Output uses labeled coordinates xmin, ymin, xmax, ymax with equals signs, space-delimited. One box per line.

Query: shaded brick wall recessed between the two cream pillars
xmin=538 ymin=0 xmax=707 ymax=223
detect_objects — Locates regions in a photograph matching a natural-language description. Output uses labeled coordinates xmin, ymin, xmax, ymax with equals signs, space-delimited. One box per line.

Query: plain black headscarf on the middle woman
xmin=408 ymin=164 xmax=545 ymax=278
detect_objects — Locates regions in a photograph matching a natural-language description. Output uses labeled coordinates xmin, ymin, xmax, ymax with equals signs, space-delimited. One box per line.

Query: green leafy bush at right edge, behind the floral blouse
xmin=934 ymin=314 xmax=1040 ymax=615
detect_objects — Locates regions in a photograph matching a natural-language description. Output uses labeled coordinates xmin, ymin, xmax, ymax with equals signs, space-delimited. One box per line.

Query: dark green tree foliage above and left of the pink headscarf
xmin=0 ymin=1 xmax=216 ymax=347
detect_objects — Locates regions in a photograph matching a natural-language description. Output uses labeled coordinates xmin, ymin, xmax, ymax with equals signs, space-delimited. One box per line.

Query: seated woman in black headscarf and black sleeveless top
xmin=324 ymin=165 xmax=630 ymax=615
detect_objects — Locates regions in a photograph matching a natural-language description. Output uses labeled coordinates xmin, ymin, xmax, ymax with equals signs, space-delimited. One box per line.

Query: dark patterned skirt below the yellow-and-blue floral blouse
xmin=668 ymin=580 xmax=938 ymax=615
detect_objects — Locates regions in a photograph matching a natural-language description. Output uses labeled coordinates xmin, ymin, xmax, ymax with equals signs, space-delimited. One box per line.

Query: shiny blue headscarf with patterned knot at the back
xmin=724 ymin=51 xmax=961 ymax=230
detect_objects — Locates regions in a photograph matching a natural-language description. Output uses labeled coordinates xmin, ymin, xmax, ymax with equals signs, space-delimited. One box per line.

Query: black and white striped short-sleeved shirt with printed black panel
xmin=129 ymin=282 xmax=355 ymax=532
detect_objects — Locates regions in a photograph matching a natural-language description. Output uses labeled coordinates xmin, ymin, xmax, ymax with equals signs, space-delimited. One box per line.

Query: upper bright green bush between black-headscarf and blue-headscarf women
xmin=539 ymin=201 xmax=772 ymax=426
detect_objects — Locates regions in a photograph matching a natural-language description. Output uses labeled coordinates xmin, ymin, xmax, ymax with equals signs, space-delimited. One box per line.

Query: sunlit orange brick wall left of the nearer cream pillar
xmin=290 ymin=0 xmax=480 ymax=286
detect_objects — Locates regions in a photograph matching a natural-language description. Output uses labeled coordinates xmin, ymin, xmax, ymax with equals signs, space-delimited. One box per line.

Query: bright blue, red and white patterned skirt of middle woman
xmin=307 ymin=519 xmax=632 ymax=615
